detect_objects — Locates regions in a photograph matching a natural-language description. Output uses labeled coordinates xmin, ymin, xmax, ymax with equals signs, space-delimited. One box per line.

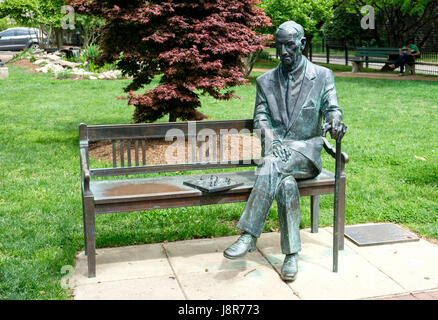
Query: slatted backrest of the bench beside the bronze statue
xmin=79 ymin=119 xmax=261 ymax=177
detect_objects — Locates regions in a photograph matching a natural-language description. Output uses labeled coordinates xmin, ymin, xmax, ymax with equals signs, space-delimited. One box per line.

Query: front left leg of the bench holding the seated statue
xmin=84 ymin=197 xmax=96 ymax=278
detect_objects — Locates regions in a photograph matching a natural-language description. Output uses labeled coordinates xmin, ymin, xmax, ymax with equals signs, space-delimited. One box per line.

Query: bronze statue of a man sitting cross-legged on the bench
xmin=224 ymin=21 xmax=346 ymax=281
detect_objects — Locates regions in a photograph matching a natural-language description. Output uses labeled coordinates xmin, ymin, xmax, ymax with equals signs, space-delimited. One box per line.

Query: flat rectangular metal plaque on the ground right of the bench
xmin=345 ymin=223 xmax=419 ymax=247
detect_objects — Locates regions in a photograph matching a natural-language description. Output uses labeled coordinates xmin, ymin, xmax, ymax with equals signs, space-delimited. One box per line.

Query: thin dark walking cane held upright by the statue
xmin=322 ymin=120 xmax=343 ymax=272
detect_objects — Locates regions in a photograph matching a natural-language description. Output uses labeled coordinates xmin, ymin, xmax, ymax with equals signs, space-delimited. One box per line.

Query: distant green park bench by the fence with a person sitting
xmin=348 ymin=47 xmax=415 ymax=74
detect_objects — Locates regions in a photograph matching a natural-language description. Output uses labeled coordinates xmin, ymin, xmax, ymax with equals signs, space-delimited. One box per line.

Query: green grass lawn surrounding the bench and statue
xmin=0 ymin=63 xmax=438 ymax=299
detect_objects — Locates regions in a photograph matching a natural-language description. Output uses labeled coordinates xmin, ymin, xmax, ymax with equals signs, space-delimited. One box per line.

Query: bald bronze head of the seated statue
xmin=275 ymin=21 xmax=306 ymax=69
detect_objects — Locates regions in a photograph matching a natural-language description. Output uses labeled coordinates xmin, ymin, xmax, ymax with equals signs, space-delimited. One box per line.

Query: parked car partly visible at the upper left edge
xmin=0 ymin=28 xmax=44 ymax=51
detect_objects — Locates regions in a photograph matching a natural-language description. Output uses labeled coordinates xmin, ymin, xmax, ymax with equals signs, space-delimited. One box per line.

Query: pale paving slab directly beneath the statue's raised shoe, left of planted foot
xmin=164 ymin=236 xmax=298 ymax=300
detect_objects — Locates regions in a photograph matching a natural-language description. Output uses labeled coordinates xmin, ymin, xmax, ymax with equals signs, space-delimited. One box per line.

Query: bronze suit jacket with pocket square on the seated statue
xmin=254 ymin=56 xmax=342 ymax=171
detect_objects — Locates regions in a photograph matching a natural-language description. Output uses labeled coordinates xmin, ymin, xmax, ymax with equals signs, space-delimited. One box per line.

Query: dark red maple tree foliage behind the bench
xmin=71 ymin=0 xmax=270 ymax=122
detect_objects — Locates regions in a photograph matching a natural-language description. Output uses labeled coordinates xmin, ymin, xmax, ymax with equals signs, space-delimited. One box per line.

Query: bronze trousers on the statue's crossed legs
xmin=237 ymin=151 xmax=319 ymax=254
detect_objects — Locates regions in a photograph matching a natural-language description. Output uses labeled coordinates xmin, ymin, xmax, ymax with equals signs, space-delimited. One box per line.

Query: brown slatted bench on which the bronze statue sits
xmin=79 ymin=119 xmax=348 ymax=277
